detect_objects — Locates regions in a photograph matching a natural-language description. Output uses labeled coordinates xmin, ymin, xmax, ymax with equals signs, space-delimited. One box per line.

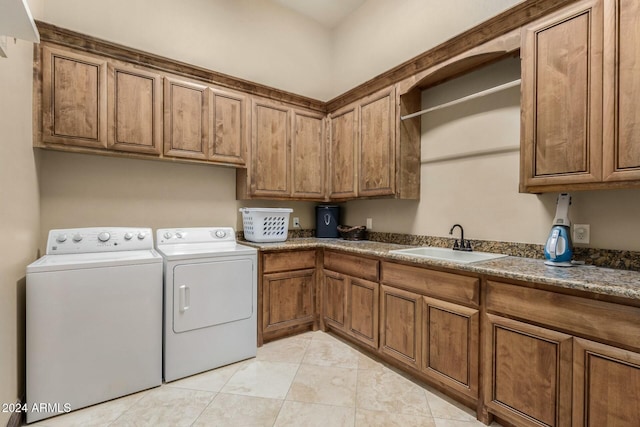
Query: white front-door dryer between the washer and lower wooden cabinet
xmin=156 ymin=227 xmax=258 ymax=381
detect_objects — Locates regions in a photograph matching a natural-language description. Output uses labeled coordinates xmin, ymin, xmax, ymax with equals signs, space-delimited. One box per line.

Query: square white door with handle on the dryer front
xmin=173 ymin=259 xmax=256 ymax=333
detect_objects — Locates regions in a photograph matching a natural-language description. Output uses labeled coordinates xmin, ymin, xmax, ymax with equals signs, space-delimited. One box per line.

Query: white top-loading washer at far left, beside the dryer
xmin=26 ymin=227 xmax=162 ymax=423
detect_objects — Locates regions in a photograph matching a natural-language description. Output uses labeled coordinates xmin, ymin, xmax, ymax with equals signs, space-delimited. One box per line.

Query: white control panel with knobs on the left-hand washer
xmin=47 ymin=227 xmax=153 ymax=255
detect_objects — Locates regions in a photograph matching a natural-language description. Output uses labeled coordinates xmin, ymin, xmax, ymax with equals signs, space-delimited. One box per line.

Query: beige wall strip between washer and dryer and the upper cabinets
xmin=38 ymin=151 xmax=313 ymax=250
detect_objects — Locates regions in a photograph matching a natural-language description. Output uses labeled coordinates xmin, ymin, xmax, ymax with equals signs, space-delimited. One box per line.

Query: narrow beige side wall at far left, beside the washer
xmin=0 ymin=2 xmax=40 ymax=426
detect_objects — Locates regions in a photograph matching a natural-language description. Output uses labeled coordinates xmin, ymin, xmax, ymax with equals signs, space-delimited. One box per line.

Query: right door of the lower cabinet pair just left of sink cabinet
xmin=347 ymin=277 xmax=380 ymax=349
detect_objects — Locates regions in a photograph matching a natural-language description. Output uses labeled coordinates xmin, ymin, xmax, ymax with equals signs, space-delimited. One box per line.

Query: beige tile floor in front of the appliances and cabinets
xmin=31 ymin=331 xmax=497 ymax=427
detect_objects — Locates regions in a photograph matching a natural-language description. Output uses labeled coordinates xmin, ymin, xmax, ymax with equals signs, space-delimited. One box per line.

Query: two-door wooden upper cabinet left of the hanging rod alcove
xmin=329 ymin=85 xmax=420 ymax=200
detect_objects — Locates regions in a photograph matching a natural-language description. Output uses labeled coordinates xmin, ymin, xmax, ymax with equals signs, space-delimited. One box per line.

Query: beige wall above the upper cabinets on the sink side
xmin=332 ymin=0 xmax=521 ymax=97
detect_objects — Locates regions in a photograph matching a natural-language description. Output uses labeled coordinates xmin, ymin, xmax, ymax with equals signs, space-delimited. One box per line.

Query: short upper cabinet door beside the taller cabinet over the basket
xmin=209 ymin=89 xmax=249 ymax=166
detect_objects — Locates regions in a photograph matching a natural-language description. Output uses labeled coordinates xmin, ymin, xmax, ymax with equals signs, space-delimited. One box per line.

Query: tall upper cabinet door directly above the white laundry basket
xmin=251 ymin=99 xmax=291 ymax=197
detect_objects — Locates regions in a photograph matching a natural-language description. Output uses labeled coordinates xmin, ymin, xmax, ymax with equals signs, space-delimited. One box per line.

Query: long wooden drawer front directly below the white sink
xmin=380 ymin=262 xmax=480 ymax=307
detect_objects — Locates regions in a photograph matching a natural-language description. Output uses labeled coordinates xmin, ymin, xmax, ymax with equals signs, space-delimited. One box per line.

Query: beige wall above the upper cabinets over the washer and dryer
xmin=38 ymin=0 xmax=333 ymax=100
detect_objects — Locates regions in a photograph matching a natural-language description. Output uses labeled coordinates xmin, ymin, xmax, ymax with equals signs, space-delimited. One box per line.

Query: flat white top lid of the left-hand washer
xmin=27 ymin=249 xmax=162 ymax=273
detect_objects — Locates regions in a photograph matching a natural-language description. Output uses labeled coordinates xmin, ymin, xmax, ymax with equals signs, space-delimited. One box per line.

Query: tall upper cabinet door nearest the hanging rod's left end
xmin=358 ymin=87 xmax=396 ymax=196
